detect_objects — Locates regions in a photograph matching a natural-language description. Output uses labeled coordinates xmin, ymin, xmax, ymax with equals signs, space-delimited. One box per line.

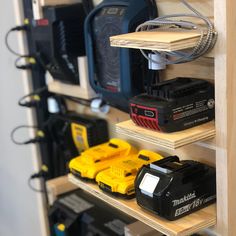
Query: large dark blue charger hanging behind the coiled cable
xmin=85 ymin=0 xmax=157 ymax=111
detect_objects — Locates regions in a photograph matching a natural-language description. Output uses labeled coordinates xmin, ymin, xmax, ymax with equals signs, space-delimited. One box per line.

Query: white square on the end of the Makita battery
xmin=139 ymin=173 xmax=160 ymax=197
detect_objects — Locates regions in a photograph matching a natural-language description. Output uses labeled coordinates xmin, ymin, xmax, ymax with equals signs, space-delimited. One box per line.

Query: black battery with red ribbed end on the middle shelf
xmin=130 ymin=77 xmax=215 ymax=132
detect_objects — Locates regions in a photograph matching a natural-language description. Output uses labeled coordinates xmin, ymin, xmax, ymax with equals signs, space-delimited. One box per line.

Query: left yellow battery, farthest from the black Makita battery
xmin=69 ymin=139 xmax=137 ymax=179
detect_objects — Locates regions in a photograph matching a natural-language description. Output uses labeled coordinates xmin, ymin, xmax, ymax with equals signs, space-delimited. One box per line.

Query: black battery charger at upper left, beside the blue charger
xmin=32 ymin=3 xmax=86 ymax=84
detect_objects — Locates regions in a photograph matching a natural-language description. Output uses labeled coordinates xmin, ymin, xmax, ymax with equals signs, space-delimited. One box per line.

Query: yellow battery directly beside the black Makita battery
xmin=96 ymin=150 xmax=163 ymax=198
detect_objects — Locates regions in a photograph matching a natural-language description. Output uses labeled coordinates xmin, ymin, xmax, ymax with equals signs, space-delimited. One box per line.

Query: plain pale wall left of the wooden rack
xmin=0 ymin=0 xmax=45 ymax=236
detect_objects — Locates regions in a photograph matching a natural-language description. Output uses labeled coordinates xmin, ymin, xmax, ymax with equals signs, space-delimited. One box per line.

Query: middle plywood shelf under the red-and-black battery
xmin=116 ymin=120 xmax=215 ymax=150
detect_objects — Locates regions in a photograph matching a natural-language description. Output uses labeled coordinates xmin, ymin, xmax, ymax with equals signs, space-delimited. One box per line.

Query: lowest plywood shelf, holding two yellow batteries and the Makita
xmin=68 ymin=174 xmax=216 ymax=236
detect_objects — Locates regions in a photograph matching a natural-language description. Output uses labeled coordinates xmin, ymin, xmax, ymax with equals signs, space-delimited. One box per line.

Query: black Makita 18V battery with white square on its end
xmin=135 ymin=156 xmax=216 ymax=220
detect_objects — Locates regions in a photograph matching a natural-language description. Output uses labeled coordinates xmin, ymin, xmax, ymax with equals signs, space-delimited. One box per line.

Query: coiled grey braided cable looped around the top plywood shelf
xmin=136 ymin=0 xmax=217 ymax=65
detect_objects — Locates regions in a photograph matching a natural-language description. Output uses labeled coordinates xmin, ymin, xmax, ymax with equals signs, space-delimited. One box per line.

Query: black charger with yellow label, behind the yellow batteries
xmin=47 ymin=112 xmax=109 ymax=176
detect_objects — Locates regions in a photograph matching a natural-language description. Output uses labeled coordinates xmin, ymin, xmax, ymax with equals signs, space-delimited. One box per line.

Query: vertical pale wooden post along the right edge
xmin=214 ymin=0 xmax=236 ymax=236
